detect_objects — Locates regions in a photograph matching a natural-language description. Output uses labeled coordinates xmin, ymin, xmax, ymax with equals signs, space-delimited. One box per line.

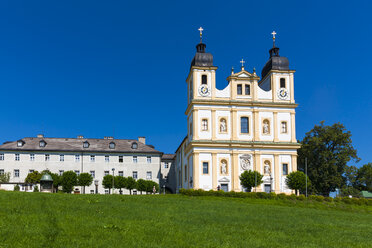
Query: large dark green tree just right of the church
xmin=298 ymin=121 xmax=360 ymax=196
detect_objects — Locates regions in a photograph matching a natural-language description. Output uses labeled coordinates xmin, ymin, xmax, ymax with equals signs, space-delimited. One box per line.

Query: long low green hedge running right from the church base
xmin=179 ymin=189 xmax=372 ymax=206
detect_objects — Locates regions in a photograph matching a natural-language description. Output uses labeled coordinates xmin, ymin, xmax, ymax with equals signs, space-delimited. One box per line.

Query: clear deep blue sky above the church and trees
xmin=0 ymin=0 xmax=372 ymax=166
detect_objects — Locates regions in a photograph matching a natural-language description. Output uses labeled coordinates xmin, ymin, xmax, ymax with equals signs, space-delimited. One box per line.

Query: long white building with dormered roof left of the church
xmin=0 ymin=135 xmax=167 ymax=194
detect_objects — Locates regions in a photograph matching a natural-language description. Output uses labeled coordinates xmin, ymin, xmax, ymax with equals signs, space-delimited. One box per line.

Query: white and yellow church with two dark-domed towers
xmin=175 ymin=28 xmax=300 ymax=194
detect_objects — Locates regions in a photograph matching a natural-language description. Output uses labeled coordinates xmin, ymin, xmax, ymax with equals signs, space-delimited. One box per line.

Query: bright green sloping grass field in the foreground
xmin=0 ymin=192 xmax=372 ymax=248
